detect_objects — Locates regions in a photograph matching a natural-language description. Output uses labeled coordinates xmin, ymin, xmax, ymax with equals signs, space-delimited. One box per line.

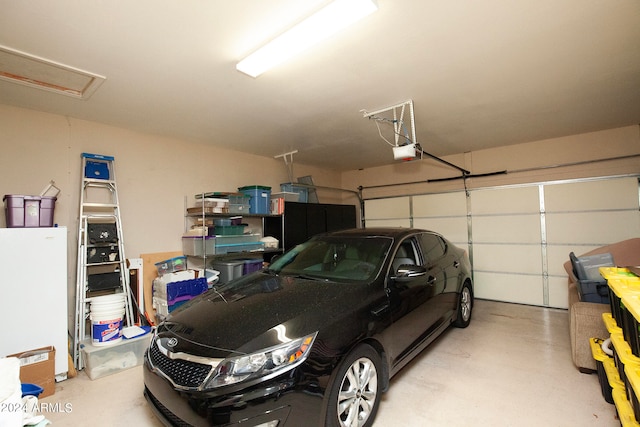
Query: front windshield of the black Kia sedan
xmin=268 ymin=236 xmax=392 ymax=282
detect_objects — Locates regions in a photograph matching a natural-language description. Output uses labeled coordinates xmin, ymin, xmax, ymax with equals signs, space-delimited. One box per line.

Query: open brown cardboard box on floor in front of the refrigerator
xmin=7 ymin=346 xmax=56 ymax=397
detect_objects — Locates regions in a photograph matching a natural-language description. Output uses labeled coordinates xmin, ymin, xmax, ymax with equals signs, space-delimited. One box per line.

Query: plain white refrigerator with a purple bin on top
xmin=0 ymin=227 xmax=68 ymax=381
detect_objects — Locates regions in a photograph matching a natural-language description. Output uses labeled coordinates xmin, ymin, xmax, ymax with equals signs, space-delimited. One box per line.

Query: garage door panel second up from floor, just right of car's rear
xmin=473 ymin=243 xmax=542 ymax=274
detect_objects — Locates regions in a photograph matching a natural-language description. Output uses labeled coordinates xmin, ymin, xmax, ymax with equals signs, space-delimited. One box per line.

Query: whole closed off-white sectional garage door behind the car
xmin=365 ymin=177 xmax=640 ymax=308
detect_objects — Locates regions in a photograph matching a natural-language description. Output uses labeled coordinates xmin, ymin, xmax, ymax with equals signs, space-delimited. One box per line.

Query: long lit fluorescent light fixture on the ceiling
xmin=236 ymin=0 xmax=378 ymax=77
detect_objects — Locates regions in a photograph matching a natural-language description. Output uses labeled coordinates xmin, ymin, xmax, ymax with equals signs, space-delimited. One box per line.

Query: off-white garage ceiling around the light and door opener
xmin=0 ymin=0 xmax=640 ymax=170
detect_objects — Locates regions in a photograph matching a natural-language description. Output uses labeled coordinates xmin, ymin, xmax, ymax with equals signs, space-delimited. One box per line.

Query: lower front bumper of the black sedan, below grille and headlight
xmin=143 ymin=354 xmax=323 ymax=427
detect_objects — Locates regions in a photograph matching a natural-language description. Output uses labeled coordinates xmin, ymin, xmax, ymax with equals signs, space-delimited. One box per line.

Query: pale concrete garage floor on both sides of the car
xmin=41 ymin=301 xmax=620 ymax=427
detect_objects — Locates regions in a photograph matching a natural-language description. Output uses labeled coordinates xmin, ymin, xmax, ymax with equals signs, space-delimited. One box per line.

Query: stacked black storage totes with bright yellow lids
xmin=590 ymin=267 xmax=640 ymax=427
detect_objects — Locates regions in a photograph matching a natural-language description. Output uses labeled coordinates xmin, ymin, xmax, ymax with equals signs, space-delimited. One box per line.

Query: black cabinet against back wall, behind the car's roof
xmin=284 ymin=202 xmax=357 ymax=250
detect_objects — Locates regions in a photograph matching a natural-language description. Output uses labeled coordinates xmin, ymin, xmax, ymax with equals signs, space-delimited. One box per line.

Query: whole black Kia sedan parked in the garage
xmin=144 ymin=228 xmax=473 ymax=427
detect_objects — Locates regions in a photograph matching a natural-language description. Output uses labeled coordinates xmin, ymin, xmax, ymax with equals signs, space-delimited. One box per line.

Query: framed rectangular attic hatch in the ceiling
xmin=0 ymin=46 xmax=106 ymax=99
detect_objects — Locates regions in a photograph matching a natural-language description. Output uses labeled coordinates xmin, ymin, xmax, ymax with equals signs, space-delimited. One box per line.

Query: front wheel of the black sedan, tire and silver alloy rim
xmin=325 ymin=344 xmax=382 ymax=427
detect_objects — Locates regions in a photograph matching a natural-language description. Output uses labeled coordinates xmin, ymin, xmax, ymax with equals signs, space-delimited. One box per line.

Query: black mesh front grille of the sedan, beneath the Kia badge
xmin=149 ymin=341 xmax=212 ymax=388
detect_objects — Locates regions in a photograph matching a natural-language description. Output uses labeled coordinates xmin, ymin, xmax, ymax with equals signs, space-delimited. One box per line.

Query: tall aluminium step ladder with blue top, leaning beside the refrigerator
xmin=73 ymin=153 xmax=134 ymax=370
